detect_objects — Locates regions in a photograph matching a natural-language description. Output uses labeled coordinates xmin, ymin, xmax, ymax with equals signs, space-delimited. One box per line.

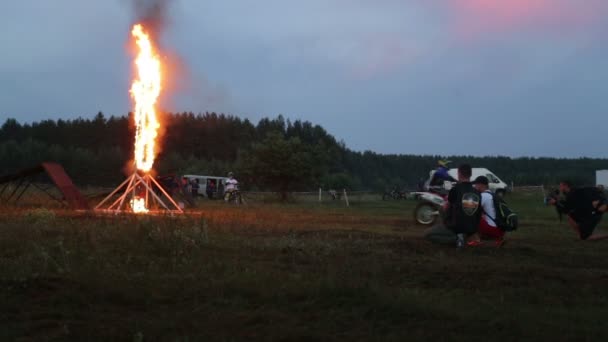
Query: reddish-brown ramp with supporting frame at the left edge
xmin=0 ymin=162 xmax=89 ymax=210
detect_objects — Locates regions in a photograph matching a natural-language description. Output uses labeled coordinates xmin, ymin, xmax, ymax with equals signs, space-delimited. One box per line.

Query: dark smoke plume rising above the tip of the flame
xmin=131 ymin=0 xmax=176 ymax=37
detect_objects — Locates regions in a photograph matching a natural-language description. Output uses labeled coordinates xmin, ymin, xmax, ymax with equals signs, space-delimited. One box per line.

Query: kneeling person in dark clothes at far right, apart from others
xmin=549 ymin=181 xmax=608 ymax=241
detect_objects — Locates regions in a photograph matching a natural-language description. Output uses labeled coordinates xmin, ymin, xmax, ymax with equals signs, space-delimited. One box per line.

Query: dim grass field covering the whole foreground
xmin=0 ymin=194 xmax=608 ymax=341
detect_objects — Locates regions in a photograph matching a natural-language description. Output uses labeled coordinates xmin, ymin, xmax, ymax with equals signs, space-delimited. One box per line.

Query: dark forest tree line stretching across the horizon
xmin=0 ymin=112 xmax=608 ymax=193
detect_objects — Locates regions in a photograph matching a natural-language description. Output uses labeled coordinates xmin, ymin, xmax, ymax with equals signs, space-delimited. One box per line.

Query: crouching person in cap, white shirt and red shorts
xmin=473 ymin=176 xmax=505 ymax=247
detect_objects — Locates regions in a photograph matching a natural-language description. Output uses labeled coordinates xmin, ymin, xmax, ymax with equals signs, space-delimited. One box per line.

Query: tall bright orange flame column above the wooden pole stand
xmin=131 ymin=24 xmax=161 ymax=172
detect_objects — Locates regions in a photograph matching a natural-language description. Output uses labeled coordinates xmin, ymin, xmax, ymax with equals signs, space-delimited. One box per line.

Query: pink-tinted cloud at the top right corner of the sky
xmin=447 ymin=0 xmax=608 ymax=38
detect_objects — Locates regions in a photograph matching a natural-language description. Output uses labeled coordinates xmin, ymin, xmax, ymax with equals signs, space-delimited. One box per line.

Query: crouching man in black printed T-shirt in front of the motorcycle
xmin=445 ymin=164 xmax=482 ymax=247
